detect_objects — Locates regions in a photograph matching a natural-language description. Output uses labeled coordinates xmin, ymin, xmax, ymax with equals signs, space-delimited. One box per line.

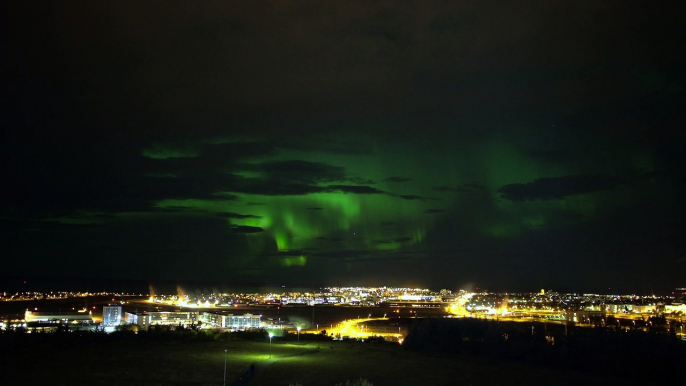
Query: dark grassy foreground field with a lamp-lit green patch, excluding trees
xmin=0 ymin=333 xmax=652 ymax=386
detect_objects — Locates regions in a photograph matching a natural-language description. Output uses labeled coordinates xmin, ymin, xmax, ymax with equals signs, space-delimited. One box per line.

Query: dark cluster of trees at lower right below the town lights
xmin=403 ymin=319 xmax=686 ymax=381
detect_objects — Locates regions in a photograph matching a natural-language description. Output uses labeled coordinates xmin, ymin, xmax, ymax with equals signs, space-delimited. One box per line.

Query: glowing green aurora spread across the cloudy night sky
xmin=144 ymin=134 xmax=652 ymax=276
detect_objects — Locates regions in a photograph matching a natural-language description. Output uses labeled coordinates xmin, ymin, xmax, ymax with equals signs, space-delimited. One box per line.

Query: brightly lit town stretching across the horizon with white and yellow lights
xmin=0 ymin=287 xmax=686 ymax=343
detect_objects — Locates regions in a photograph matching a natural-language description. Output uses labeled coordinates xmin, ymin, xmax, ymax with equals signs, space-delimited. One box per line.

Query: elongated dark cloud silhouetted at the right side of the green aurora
xmin=498 ymin=175 xmax=621 ymax=201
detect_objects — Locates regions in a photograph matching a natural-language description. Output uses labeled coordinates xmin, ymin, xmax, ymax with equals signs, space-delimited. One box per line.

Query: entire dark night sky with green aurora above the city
xmin=0 ymin=1 xmax=686 ymax=293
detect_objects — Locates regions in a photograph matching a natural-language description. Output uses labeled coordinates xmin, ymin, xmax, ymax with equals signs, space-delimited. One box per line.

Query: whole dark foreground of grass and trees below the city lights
xmin=5 ymin=322 xmax=684 ymax=385
